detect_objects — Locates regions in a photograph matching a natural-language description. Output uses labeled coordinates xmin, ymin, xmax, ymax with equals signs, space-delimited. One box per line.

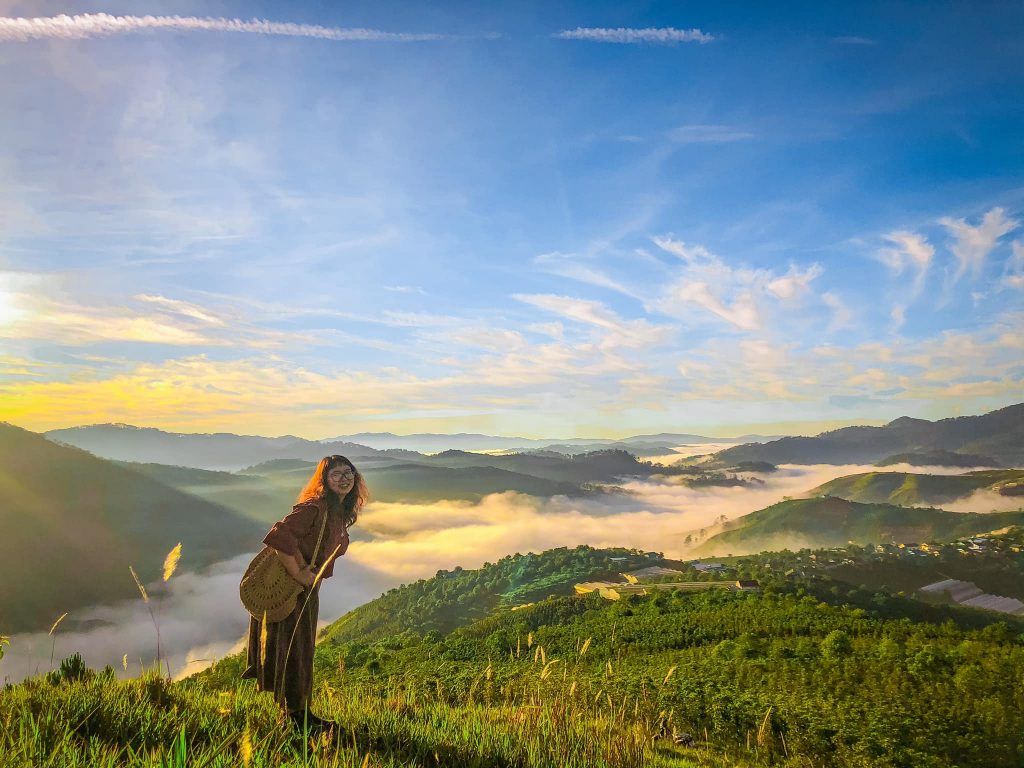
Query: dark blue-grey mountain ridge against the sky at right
xmin=715 ymin=403 xmax=1024 ymax=467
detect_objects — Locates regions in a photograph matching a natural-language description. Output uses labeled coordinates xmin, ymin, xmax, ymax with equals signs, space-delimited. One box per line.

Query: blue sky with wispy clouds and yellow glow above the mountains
xmin=0 ymin=0 xmax=1024 ymax=437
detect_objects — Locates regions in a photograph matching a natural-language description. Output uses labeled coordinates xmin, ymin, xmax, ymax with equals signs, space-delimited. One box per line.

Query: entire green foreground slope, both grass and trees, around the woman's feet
xmin=0 ymin=547 xmax=1024 ymax=768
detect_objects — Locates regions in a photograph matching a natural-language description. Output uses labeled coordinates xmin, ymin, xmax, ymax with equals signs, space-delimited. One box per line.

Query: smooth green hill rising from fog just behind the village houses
xmin=695 ymin=497 xmax=1024 ymax=555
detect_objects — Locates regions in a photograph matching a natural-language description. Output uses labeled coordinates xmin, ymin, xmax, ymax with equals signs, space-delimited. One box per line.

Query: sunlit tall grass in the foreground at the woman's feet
xmin=0 ymin=667 xmax=754 ymax=768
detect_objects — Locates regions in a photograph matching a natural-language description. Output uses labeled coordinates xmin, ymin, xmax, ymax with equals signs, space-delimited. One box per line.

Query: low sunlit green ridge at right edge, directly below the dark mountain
xmin=808 ymin=469 xmax=1024 ymax=508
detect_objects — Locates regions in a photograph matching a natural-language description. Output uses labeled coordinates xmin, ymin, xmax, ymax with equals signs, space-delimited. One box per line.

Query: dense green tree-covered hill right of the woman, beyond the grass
xmin=199 ymin=547 xmax=1024 ymax=768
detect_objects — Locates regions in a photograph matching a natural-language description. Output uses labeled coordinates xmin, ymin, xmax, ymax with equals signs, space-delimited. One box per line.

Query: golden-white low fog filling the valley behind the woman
xmin=0 ymin=460 xmax=1007 ymax=682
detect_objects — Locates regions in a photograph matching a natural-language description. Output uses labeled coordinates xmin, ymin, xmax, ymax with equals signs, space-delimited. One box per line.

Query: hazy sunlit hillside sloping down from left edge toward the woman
xmin=0 ymin=424 xmax=263 ymax=633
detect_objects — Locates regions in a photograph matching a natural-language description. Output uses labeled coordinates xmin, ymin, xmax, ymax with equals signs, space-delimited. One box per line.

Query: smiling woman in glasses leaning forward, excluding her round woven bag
xmin=242 ymin=456 xmax=367 ymax=729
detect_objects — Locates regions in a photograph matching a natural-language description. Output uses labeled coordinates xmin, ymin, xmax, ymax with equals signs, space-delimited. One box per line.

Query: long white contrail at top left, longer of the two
xmin=0 ymin=13 xmax=449 ymax=43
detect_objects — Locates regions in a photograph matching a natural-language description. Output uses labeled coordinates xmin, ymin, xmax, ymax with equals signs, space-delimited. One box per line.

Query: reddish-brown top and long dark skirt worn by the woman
xmin=242 ymin=501 xmax=348 ymax=713
